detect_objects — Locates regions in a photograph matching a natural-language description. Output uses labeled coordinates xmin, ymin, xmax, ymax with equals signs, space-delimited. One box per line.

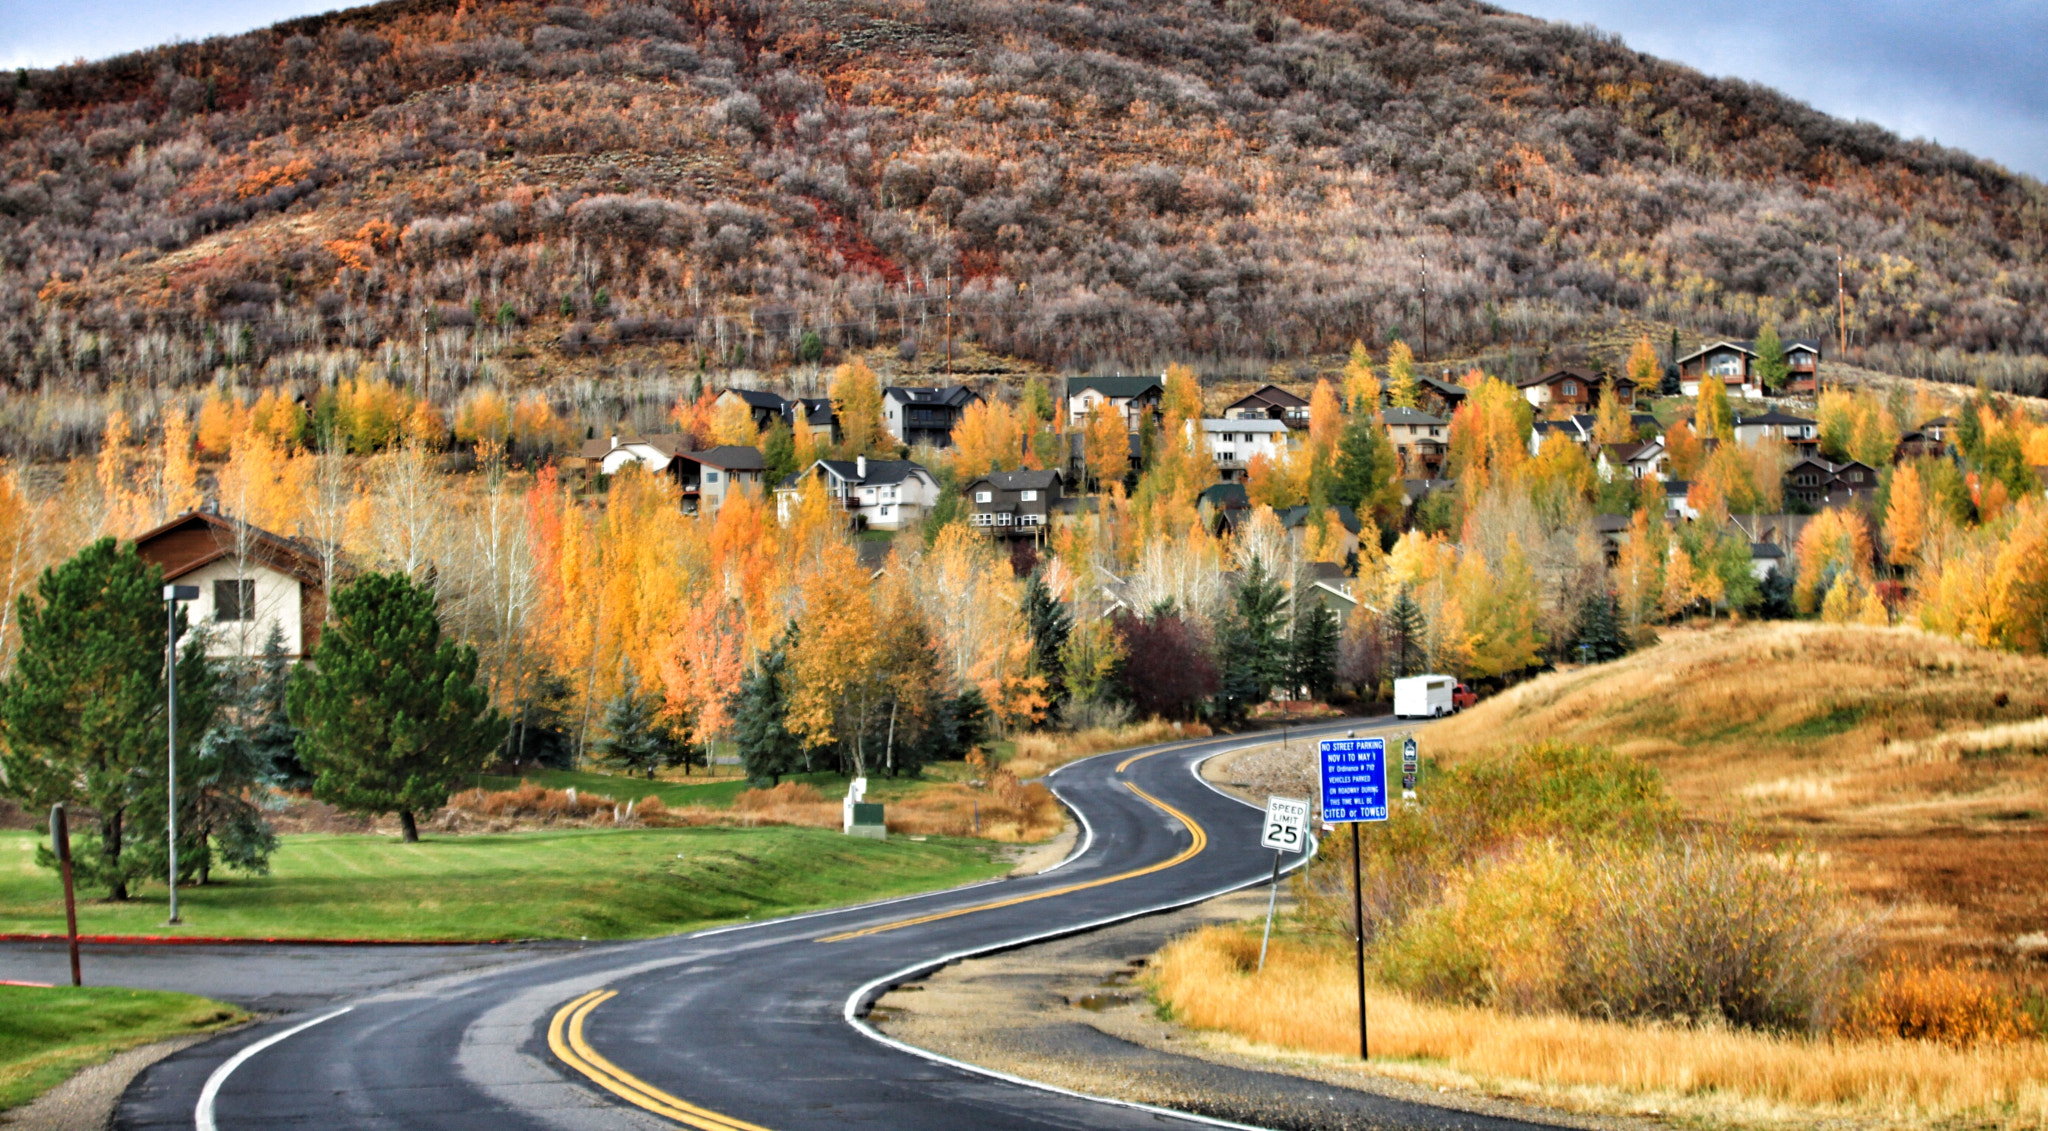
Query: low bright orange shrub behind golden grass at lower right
xmin=1835 ymin=967 xmax=2038 ymax=1049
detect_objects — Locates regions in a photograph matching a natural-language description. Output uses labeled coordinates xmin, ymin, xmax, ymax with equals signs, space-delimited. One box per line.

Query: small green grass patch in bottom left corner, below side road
xmin=0 ymin=986 xmax=244 ymax=1111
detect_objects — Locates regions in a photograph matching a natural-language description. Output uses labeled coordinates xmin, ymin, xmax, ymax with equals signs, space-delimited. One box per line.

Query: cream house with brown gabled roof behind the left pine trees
xmin=135 ymin=510 xmax=328 ymax=660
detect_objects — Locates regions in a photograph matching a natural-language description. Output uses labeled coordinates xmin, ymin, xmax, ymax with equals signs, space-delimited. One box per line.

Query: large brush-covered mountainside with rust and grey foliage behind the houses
xmin=0 ymin=0 xmax=2048 ymax=447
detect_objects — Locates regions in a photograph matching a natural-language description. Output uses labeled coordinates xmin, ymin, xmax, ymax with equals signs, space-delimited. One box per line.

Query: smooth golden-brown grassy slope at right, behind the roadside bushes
xmin=1427 ymin=623 xmax=2048 ymax=961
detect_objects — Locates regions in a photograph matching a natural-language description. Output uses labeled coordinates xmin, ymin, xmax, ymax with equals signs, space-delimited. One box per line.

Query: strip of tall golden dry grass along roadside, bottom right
xmin=1149 ymin=926 xmax=2048 ymax=1129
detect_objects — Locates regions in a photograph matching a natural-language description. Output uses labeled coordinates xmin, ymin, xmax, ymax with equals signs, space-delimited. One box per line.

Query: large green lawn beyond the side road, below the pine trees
xmin=0 ymin=828 xmax=1006 ymax=940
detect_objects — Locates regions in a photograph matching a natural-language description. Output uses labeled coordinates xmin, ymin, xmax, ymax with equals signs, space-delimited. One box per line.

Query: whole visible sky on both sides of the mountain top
xmin=0 ymin=0 xmax=2048 ymax=178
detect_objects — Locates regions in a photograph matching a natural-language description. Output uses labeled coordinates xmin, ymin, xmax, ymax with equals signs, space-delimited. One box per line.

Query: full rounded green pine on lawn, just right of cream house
xmin=287 ymin=574 xmax=502 ymax=842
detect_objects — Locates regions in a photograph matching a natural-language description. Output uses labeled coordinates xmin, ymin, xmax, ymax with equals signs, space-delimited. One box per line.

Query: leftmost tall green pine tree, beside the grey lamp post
xmin=0 ymin=539 xmax=209 ymax=899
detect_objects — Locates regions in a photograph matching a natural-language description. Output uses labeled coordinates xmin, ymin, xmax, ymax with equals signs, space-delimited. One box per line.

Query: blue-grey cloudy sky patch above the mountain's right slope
xmin=1495 ymin=0 xmax=2048 ymax=178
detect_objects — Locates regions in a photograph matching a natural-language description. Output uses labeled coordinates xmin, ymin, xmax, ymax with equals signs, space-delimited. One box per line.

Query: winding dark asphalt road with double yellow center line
xmin=115 ymin=723 xmax=1556 ymax=1131
